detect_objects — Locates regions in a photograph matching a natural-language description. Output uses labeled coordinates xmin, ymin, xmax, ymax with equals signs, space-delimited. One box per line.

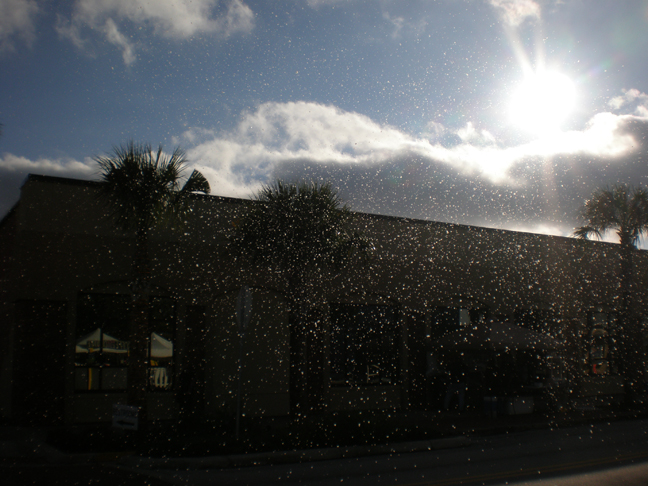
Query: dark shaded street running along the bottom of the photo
xmin=5 ymin=420 xmax=648 ymax=486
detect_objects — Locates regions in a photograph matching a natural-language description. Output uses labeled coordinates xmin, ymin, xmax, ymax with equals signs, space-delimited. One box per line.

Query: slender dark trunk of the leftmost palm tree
xmin=128 ymin=225 xmax=150 ymax=428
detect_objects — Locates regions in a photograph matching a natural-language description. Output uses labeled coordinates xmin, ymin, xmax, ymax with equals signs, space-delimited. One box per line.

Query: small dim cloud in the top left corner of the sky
xmin=0 ymin=0 xmax=40 ymax=52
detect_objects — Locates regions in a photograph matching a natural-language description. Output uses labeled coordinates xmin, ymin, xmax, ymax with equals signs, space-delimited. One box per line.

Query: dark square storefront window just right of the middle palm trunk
xmin=331 ymin=304 xmax=400 ymax=386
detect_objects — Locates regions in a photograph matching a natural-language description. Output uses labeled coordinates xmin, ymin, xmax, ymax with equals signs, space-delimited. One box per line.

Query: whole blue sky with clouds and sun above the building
xmin=0 ymin=0 xmax=648 ymax=240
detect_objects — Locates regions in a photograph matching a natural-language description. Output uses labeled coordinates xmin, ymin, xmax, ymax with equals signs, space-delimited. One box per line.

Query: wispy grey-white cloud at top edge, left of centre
xmin=57 ymin=0 xmax=254 ymax=64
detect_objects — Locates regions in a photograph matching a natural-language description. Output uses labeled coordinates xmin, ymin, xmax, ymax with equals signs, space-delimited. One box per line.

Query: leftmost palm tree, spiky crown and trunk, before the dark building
xmin=95 ymin=141 xmax=210 ymax=423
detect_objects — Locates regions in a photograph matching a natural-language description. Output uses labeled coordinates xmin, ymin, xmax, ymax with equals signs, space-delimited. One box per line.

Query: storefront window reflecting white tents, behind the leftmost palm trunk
xmin=74 ymin=294 xmax=175 ymax=391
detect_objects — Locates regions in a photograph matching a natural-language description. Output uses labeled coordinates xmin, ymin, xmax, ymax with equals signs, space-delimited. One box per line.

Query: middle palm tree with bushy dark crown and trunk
xmin=231 ymin=181 xmax=370 ymax=413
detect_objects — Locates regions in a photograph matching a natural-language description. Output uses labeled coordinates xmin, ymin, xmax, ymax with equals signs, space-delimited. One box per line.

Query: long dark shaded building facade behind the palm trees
xmin=0 ymin=175 xmax=648 ymax=423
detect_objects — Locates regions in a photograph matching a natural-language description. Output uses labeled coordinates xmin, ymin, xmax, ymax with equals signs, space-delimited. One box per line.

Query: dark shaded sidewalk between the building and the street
xmin=0 ymin=409 xmax=645 ymax=469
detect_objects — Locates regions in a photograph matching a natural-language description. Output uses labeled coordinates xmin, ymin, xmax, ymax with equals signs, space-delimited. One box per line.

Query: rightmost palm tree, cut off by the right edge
xmin=574 ymin=184 xmax=648 ymax=396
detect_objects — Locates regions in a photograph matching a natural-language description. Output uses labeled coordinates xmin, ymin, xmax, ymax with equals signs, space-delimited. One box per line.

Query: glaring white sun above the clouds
xmin=510 ymin=71 xmax=576 ymax=135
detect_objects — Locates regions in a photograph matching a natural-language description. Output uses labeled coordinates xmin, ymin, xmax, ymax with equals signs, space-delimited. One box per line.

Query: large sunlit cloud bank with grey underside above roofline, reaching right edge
xmin=168 ymin=92 xmax=648 ymax=235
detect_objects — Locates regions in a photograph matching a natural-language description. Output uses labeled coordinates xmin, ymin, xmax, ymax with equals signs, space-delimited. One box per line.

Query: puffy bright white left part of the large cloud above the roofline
xmin=183 ymin=102 xmax=429 ymax=196
